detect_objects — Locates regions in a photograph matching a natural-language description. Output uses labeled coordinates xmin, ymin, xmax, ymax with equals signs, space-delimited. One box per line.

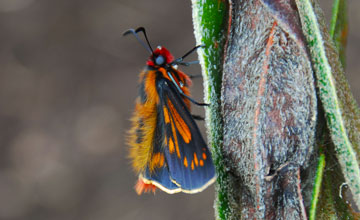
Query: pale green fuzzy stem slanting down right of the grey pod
xmin=296 ymin=0 xmax=360 ymax=211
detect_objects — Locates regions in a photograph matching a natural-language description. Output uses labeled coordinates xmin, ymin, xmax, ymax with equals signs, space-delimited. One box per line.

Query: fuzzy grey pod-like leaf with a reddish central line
xmin=221 ymin=0 xmax=317 ymax=219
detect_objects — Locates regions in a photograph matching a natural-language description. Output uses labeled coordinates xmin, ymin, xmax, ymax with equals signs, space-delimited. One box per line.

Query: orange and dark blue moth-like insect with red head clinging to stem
xmin=124 ymin=27 xmax=215 ymax=194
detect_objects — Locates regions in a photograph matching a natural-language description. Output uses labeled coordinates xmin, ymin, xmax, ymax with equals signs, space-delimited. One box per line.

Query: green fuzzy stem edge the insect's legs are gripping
xmin=192 ymin=0 xmax=230 ymax=220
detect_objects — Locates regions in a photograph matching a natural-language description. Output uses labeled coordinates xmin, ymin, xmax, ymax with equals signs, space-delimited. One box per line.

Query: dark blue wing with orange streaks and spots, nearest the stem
xmin=156 ymin=78 xmax=215 ymax=193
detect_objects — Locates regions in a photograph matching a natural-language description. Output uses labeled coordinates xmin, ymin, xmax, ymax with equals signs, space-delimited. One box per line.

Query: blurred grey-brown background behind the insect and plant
xmin=0 ymin=0 xmax=360 ymax=220
